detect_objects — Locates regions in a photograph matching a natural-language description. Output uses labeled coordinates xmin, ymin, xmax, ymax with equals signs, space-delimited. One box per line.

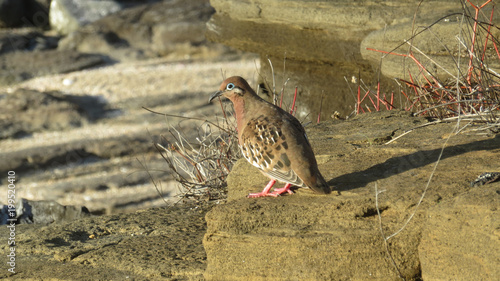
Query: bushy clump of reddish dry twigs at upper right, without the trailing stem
xmin=356 ymin=1 xmax=500 ymax=135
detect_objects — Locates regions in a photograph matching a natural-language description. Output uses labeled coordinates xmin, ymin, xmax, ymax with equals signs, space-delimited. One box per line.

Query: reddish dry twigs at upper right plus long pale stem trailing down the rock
xmin=370 ymin=0 xmax=500 ymax=280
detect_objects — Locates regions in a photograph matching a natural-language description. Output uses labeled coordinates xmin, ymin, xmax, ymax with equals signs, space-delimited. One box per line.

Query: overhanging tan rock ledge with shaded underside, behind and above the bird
xmin=206 ymin=0 xmax=472 ymax=119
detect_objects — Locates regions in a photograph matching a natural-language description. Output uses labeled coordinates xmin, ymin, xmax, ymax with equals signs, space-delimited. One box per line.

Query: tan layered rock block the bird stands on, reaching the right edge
xmin=204 ymin=112 xmax=500 ymax=280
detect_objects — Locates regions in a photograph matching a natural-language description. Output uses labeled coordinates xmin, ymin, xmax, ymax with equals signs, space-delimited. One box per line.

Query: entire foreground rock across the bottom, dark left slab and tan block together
xmin=0 ymin=112 xmax=500 ymax=280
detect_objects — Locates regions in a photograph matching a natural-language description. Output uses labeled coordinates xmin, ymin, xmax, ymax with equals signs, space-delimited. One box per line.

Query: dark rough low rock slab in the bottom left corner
xmin=0 ymin=202 xmax=211 ymax=280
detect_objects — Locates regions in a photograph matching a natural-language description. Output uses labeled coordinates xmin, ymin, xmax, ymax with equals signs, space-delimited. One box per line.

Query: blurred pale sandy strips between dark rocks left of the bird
xmin=0 ymin=55 xmax=258 ymax=213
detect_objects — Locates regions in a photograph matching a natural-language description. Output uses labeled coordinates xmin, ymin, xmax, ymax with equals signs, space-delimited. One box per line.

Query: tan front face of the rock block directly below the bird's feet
xmin=204 ymin=171 xmax=422 ymax=280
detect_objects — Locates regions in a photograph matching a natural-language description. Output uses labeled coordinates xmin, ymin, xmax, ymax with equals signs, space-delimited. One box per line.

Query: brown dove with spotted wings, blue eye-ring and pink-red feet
xmin=209 ymin=76 xmax=331 ymax=198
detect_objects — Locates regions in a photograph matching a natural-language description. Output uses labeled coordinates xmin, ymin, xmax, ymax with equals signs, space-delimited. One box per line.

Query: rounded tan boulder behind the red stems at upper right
xmin=361 ymin=13 xmax=500 ymax=81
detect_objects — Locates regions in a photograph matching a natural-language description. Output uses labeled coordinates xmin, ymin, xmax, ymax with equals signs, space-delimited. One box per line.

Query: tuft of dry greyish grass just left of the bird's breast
xmin=145 ymin=102 xmax=241 ymax=201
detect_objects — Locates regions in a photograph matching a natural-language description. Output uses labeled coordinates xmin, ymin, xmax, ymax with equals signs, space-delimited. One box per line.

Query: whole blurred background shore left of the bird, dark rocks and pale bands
xmin=0 ymin=0 xmax=257 ymax=214
